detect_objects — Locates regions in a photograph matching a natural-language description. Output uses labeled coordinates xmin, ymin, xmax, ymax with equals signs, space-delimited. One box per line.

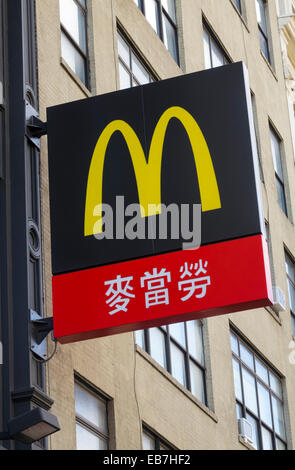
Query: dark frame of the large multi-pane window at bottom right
xmin=230 ymin=328 xmax=288 ymax=450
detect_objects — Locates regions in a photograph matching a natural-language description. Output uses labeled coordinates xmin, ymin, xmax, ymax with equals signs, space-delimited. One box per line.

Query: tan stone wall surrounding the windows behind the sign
xmin=36 ymin=0 xmax=295 ymax=449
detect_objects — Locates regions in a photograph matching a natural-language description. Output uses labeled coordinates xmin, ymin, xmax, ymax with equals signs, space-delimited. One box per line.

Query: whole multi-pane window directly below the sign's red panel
xmin=136 ymin=320 xmax=206 ymax=404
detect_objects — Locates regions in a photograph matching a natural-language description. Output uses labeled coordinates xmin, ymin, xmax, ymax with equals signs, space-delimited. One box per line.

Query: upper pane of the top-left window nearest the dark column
xmin=60 ymin=0 xmax=86 ymax=53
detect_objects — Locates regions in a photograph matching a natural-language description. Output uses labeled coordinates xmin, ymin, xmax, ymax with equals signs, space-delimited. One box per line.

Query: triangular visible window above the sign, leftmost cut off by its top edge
xmin=118 ymin=34 xmax=155 ymax=90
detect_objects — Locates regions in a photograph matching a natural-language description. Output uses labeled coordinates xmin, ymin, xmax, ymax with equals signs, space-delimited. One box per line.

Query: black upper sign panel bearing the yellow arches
xmin=47 ymin=63 xmax=262 ymax=274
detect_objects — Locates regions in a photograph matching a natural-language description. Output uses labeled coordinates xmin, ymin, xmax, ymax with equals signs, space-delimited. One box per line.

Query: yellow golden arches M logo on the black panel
xmin=84 ymin=106 xmax=221 ymax=237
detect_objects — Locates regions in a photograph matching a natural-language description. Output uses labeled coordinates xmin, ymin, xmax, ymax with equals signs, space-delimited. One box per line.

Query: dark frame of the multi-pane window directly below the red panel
xmin=135 ymin=320 xmax=208 ymax=406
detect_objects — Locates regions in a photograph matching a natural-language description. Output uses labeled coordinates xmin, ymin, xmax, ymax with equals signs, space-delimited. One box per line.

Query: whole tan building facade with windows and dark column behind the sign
xmin=0 ymin=0 xmax=295 ymax=450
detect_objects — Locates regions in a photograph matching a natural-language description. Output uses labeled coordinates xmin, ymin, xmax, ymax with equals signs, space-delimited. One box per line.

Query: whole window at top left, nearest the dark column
xmin=59 ymin=0 xmax=88 ymax=86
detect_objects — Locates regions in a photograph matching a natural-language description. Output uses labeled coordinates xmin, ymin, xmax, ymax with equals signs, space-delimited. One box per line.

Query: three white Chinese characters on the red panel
xmin=104 ymin=259 xmax=211 ymax=315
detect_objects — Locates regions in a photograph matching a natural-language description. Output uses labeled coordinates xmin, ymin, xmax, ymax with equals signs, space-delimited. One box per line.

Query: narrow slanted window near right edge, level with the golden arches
xmin=270 ymin=127 xmax=288 ymax=216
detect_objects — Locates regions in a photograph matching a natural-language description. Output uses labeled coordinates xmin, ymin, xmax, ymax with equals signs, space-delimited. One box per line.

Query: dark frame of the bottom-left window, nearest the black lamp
xmin=74 ymin=374 xmax=110 ymax=449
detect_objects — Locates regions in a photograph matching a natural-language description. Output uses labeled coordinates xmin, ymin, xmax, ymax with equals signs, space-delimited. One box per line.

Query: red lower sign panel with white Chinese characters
xmin=53 ymin=235 xmax=272 ymax=343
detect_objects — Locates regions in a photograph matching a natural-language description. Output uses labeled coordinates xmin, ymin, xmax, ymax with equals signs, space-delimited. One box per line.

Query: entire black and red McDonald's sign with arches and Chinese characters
xmin=47 ymin=63 xmax=272 ymax=343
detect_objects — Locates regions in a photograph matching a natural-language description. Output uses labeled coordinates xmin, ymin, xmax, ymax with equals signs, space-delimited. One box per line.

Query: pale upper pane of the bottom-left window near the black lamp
xmin=75 ymin=384 xmax=108 ymax=433
